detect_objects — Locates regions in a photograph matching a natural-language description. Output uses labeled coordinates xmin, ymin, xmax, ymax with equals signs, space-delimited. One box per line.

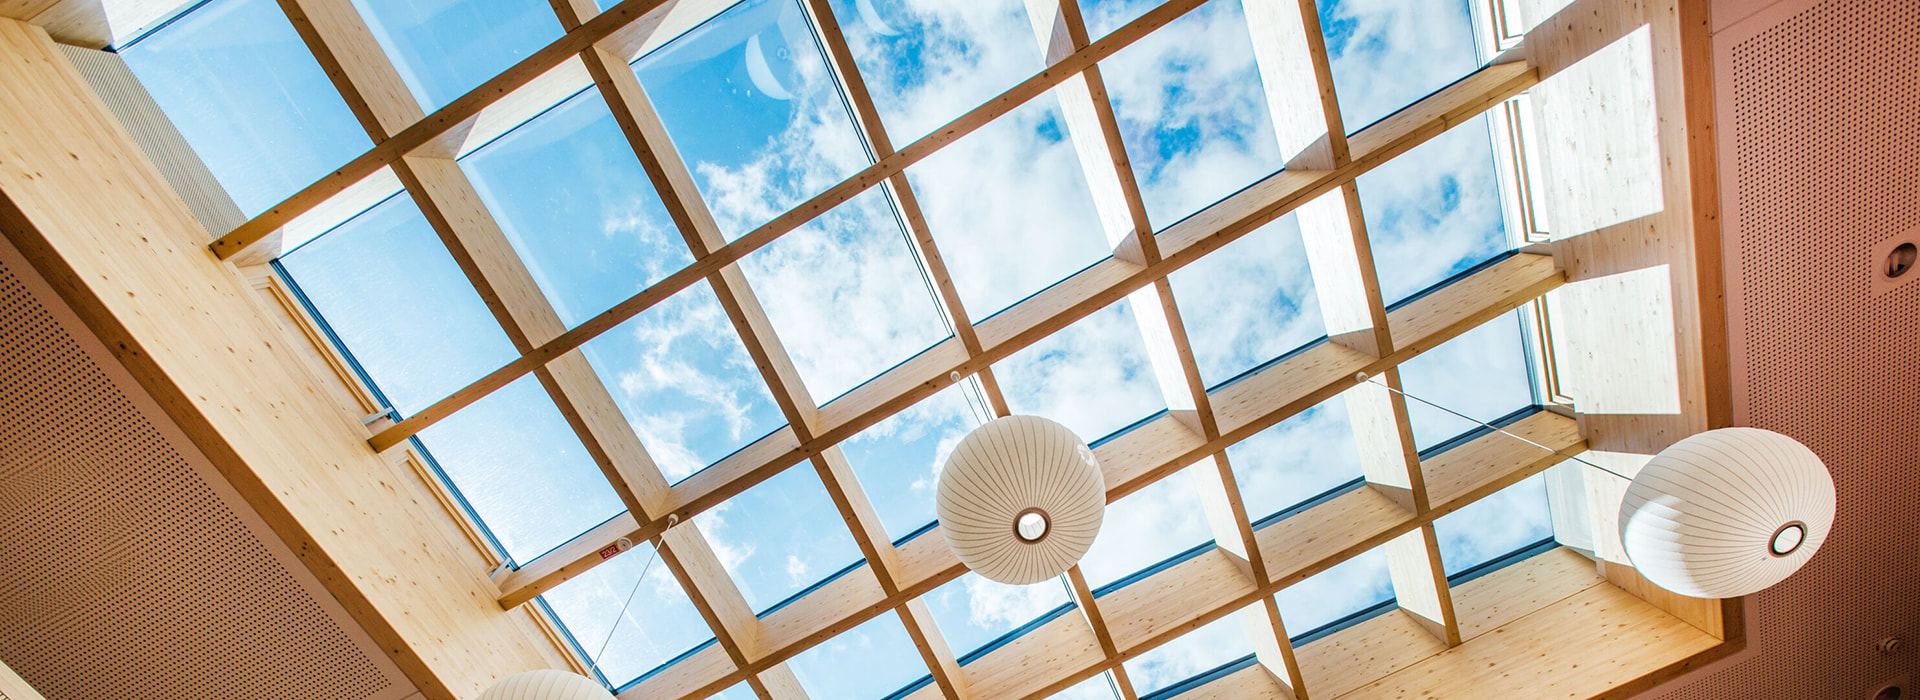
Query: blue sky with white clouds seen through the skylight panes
xmin=123 ymin=0 xmax=1549 ymax=700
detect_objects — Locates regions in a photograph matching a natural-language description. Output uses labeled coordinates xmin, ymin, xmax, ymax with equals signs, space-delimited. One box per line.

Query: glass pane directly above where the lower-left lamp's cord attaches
xmin=582 ymin=280 xmax=785 ymax=481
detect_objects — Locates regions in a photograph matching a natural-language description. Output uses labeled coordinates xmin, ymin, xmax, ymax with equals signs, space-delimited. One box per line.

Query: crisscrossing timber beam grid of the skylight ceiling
xmin=211 ymin=0 xmax=1584 ymax=700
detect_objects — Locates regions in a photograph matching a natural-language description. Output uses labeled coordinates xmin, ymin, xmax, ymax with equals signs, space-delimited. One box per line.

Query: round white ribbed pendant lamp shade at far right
xmin=1620 ymin=428 xmax=1834 ymax=598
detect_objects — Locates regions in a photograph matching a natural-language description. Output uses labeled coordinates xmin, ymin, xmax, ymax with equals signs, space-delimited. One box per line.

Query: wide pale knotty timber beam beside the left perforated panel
xmin=0 ymin=19 xmax=566 ymax=700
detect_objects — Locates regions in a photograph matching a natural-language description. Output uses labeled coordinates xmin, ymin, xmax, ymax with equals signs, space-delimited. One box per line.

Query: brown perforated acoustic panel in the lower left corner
xmin=0 ymin=235 xmax=413 ymax=700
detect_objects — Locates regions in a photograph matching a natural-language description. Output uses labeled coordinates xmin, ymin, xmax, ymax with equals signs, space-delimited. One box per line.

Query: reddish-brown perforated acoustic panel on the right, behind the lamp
xmin=1649 ymin=0 xmax=1920 ymax=700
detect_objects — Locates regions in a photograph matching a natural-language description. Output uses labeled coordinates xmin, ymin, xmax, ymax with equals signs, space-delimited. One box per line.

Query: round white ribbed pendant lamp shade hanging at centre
xmin=937 ymin=416 xmax=1106 ymax=585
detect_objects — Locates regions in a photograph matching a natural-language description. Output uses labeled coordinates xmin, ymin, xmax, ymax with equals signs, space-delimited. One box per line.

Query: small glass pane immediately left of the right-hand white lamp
xmin=1434 ymin=474 xmax=1553 ymax=575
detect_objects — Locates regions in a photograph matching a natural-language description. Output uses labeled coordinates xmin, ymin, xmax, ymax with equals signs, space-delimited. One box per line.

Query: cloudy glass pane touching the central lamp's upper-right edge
xmin=993 ymin=299 xmax=1167 ymax=443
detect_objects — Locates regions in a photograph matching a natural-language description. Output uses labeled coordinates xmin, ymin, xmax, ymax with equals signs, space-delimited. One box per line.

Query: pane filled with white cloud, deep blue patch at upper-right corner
xmin=906 ymin=94 xmax=1112 ymax=322
